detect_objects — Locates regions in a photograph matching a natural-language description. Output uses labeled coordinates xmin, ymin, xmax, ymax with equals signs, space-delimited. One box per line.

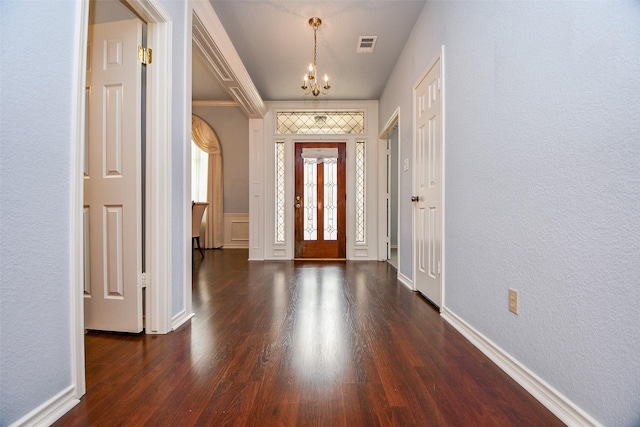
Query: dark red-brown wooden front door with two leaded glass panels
xmin=295 ymin=143 xmax=346 ymax=259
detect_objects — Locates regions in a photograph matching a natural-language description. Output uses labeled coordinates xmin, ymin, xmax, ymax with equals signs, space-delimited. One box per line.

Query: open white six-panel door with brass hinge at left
xmin=84 ymin=19 xmax=142 ymax=332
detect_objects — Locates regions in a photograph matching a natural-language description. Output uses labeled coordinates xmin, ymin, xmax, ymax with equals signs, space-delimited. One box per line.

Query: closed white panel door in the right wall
xmin=414 ymin=56 xmax=442 ymax=307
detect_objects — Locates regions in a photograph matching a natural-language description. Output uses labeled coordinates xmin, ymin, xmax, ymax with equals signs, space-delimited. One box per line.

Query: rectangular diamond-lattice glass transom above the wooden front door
xmin=276 ymin=111 xmax=364 ymax=135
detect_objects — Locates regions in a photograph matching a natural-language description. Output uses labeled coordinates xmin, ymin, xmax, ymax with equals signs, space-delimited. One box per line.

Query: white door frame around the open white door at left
xmin=69 ymin=0 xmax=172 ymax=399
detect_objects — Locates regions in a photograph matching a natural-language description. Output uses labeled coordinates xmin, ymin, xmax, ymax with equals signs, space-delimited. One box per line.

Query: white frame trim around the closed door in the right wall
xmin=411 ymin=45 xmax=446 ymax=312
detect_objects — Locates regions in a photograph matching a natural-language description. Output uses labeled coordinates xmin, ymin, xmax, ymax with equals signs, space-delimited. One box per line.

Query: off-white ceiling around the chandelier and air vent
xmin=193 ymin=0 xmax=425 ymax=101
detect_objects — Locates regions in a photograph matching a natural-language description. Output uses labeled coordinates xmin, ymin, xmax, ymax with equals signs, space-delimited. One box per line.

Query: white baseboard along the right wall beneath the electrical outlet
xmin=441 ymin=307 xmax=602 ymax=427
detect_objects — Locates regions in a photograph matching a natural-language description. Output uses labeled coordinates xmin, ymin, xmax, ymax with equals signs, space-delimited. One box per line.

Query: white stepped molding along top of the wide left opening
xmin=192 ymin=1 xmax=267 ymax=119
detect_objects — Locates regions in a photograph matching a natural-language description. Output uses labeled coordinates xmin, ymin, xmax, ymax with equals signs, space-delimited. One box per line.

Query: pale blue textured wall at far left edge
xmin=0 ymin=0 xmax=76 ymax=425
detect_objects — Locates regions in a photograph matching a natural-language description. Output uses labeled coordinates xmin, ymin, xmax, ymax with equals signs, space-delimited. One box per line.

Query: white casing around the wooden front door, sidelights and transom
xmin=249 ymin=101 xmax=378 ymax=261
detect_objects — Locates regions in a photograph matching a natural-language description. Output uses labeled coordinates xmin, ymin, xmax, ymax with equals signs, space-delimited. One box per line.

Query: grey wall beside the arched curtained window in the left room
xmin=193 ymin=107 xmax=249 ymax=213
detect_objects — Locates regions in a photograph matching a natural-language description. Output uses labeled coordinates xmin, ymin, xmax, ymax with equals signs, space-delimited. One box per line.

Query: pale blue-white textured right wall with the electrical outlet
xmin=380 ymin=1 xmax=640 ymax=426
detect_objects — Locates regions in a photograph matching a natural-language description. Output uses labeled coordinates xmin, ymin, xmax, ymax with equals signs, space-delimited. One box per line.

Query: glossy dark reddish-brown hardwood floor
xmin=55 ymin=249 xmax=562 ymax=427
